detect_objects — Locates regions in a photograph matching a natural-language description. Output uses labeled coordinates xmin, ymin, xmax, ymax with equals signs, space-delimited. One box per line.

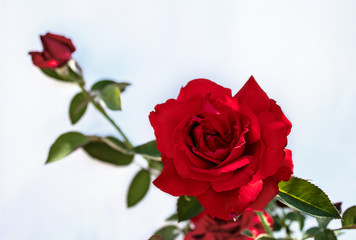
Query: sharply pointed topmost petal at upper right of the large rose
xmin=235 ymin=76 xmax=269 ymax=113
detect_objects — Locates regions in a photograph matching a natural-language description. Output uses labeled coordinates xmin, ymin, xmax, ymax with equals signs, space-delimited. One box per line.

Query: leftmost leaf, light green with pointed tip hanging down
xmin=46 ymin=132 xmax=88 ymax=164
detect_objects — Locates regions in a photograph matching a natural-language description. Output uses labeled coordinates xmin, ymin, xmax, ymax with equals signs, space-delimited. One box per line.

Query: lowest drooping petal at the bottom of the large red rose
xmin=196 ymin=181 xmax=263 ymax=220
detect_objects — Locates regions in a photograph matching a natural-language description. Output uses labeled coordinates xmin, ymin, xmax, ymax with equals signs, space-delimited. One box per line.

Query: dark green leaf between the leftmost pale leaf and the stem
xmin=83 ymin=138 xmax=133 ymax=166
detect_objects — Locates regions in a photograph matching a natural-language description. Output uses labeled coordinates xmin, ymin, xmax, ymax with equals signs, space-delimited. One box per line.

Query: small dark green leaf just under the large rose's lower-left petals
xmin=177 ymin=196 xmax=204 ymax=222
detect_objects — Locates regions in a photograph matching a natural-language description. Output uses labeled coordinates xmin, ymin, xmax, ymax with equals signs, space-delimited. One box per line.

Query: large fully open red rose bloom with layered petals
xmin=149 ymin=76 xmax=293 ymax=220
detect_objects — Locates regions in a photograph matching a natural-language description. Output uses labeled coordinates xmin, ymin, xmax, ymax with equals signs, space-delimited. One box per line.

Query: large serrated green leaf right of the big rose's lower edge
xmin=277 ymin=177 xmax=340 ymax=218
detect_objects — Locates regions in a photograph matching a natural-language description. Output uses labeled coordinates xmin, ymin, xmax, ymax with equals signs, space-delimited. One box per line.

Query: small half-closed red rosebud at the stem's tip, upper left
xmin=29 ymin=33 xmax=75 ymax=68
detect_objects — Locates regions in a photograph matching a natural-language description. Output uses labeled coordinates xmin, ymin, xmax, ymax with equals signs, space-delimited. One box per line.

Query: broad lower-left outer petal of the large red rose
xmin=153 ymin=158 xmax=210 ymax=196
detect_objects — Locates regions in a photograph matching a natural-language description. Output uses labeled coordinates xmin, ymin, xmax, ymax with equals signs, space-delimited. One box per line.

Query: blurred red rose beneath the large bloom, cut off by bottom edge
xmin=184 ymin=210 xmax=273 ymax=240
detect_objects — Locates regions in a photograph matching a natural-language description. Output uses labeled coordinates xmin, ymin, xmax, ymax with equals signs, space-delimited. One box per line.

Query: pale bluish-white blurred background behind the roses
xmin=0 ymin=0 xmax=356 ymax=240
